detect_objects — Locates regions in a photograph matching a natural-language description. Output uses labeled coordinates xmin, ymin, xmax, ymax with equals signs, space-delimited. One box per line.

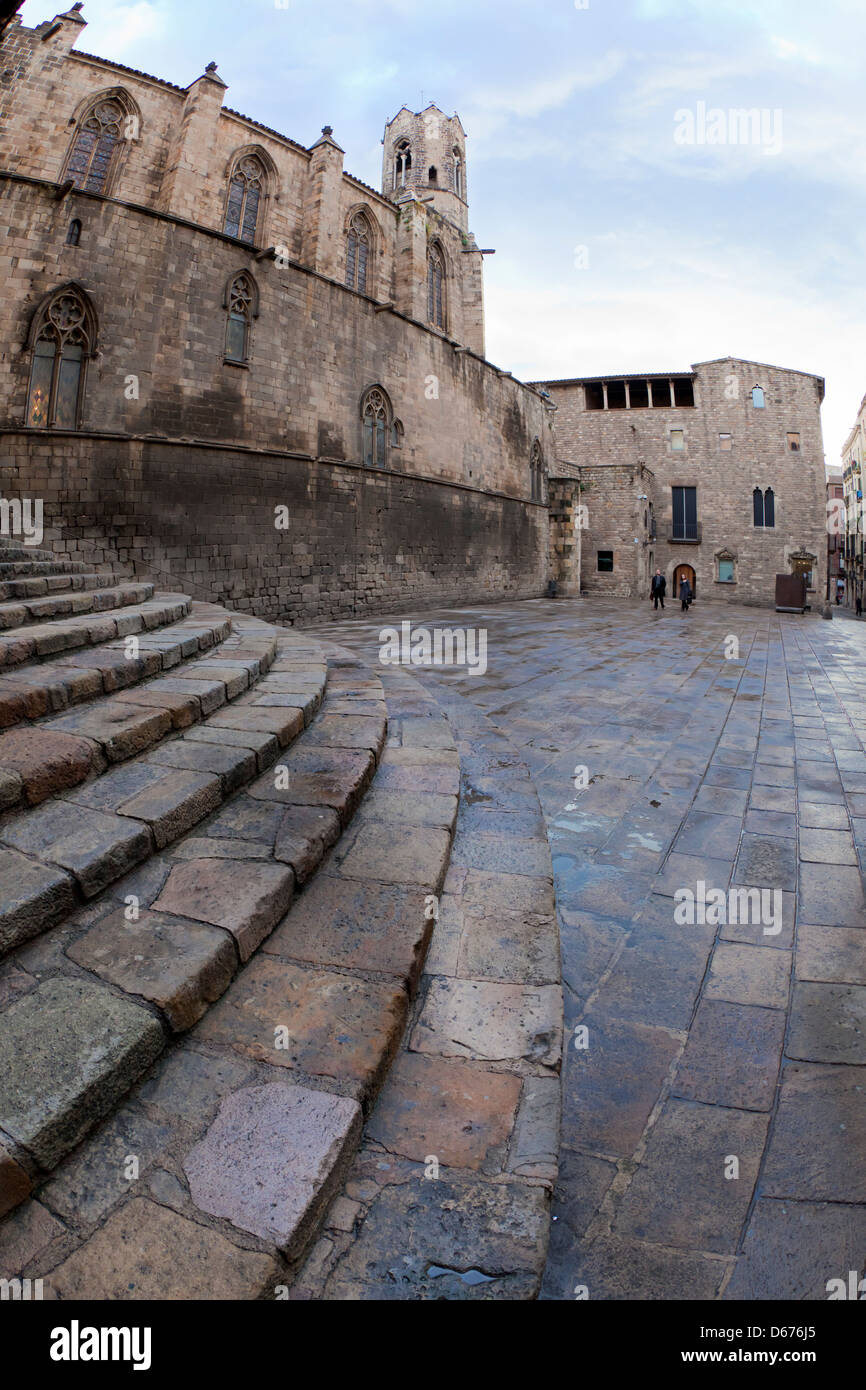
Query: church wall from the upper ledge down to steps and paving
xmin=0 ymin=178 xmax=553 ymax=621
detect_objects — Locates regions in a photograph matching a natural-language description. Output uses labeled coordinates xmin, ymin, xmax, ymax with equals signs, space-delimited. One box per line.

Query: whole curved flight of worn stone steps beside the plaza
xmin=0 ymin=546 xmax=459 ymax=1298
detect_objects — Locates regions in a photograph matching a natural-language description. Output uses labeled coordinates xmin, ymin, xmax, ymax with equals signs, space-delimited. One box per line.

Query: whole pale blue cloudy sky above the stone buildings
xmin=22 ymin=0 xmax=866 ymax=466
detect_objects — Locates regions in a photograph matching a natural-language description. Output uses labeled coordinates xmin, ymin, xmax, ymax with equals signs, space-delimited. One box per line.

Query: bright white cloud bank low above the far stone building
xmin=485 ymin=228 xmax=866 ymax=464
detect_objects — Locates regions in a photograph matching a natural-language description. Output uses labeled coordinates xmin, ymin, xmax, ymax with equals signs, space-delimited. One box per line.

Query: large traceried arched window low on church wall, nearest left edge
xmin=25 ymin=285 xmax=96 ymax=430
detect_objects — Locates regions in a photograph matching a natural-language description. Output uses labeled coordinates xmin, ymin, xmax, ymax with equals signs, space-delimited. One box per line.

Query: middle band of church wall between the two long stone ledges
xmin=0 ymin=177 xmax=553 ymax=499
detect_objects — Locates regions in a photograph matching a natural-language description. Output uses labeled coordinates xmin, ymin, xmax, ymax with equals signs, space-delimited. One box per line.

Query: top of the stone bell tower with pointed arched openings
xmin=382 ymin=101 xmax=468 ymax=232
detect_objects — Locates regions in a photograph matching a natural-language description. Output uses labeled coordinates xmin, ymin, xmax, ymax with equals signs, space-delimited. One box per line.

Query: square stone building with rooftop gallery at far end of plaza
xmin=545 ymin=357 xmax=827 ymax=606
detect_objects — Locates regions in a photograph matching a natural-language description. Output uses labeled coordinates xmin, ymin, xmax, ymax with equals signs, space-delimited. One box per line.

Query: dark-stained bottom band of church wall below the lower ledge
xmin=0 ymin=431 xmax=548 ymax=624
